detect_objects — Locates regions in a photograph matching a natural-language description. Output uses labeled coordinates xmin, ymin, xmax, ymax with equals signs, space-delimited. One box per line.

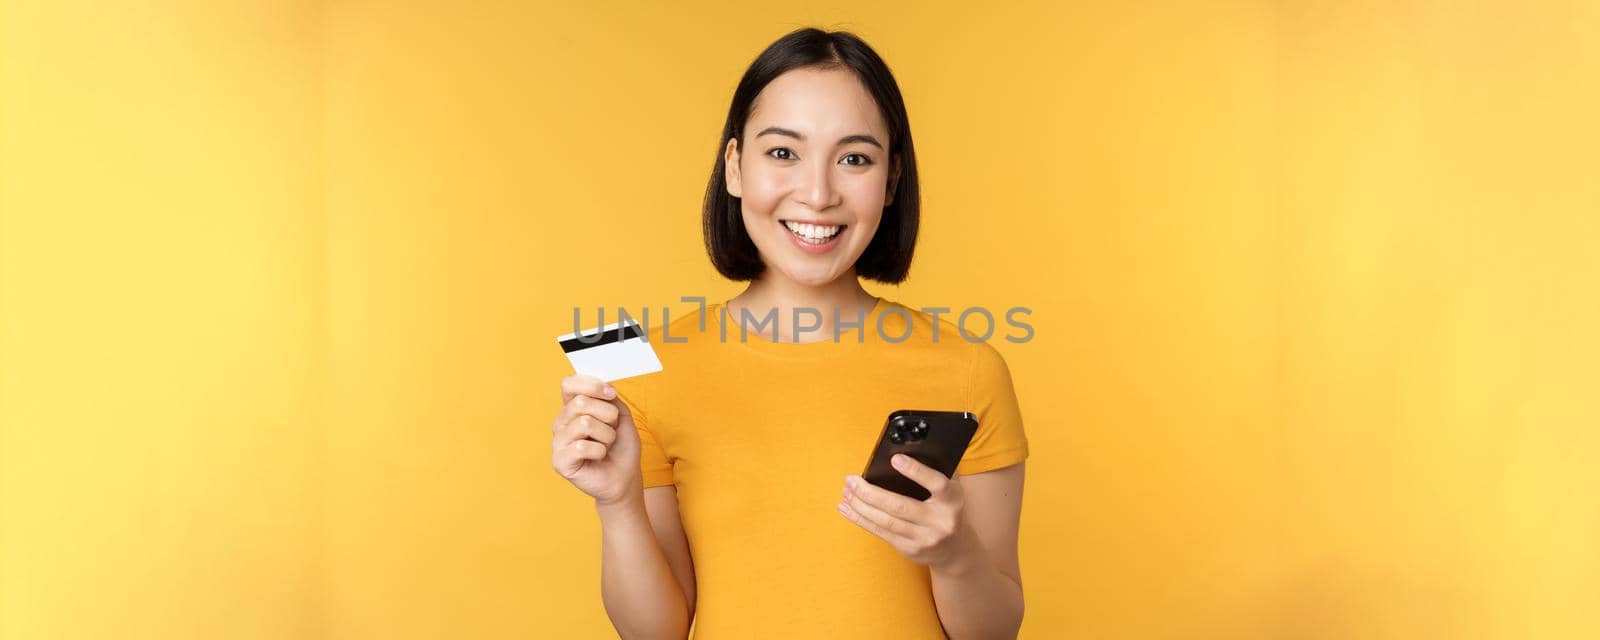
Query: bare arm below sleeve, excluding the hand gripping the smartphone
xmin=930 ymin=462 xmax=1027 ymax=638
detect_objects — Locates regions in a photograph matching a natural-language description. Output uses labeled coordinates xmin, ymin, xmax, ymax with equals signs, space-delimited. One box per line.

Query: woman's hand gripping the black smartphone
xmin=838 ymin=453 xmax=973 ymax=566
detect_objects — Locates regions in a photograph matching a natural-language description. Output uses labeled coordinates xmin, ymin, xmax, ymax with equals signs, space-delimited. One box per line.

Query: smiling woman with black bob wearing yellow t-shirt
xmin=552 ymin=29 xmax=1027 ymax=640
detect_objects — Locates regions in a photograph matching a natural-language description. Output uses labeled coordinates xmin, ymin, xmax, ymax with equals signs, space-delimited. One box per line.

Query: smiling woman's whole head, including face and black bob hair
xmin=704 ymin=30 xmax=922 ymax=301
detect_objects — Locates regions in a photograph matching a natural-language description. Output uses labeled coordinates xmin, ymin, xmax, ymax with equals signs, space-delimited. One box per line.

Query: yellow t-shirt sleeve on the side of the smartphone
xmin=955 ymin=342 xmax=1027 ymax=475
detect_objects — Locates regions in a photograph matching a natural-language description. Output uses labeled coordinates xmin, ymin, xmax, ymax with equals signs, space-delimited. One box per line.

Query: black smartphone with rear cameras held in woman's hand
xmin=861 ymin=410 xmax=978 ymax=499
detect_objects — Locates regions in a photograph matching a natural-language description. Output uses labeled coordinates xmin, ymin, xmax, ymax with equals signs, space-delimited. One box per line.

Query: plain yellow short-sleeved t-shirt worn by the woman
xmin=614 ymin=298 xmax=1027 ymax=640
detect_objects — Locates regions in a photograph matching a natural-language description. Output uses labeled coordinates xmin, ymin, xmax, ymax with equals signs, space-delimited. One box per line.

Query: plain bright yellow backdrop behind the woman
xmin=0 ymin=0 xmax=1600 ymax=640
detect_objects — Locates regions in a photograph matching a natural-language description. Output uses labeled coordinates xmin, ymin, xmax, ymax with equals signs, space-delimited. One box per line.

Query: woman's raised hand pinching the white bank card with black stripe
xmin=550 ymin=374 xmax=645 ymax=504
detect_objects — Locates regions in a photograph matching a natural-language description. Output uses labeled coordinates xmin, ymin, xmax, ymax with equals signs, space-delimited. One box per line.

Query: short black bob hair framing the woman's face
xmin=701 ymin=27 xmax=922 ymax=285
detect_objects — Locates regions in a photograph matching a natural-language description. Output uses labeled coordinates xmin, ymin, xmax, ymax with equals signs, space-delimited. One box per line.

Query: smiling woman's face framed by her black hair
xmin=723 ymin=67 xmax=899 ymax=286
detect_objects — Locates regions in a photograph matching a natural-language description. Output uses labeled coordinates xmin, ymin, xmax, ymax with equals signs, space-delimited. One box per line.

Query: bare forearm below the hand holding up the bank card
xmin=595 ymin=486 xmax=694 ymax=640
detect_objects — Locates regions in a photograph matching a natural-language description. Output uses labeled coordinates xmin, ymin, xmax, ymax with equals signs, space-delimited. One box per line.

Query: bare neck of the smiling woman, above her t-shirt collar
xmin=726 ymin=270 xmax=878 ymax=342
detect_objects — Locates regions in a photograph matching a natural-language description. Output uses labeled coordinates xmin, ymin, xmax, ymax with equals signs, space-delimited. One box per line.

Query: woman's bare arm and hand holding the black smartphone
xmin=838 ymin=454 xmax=1026 ymax=638
